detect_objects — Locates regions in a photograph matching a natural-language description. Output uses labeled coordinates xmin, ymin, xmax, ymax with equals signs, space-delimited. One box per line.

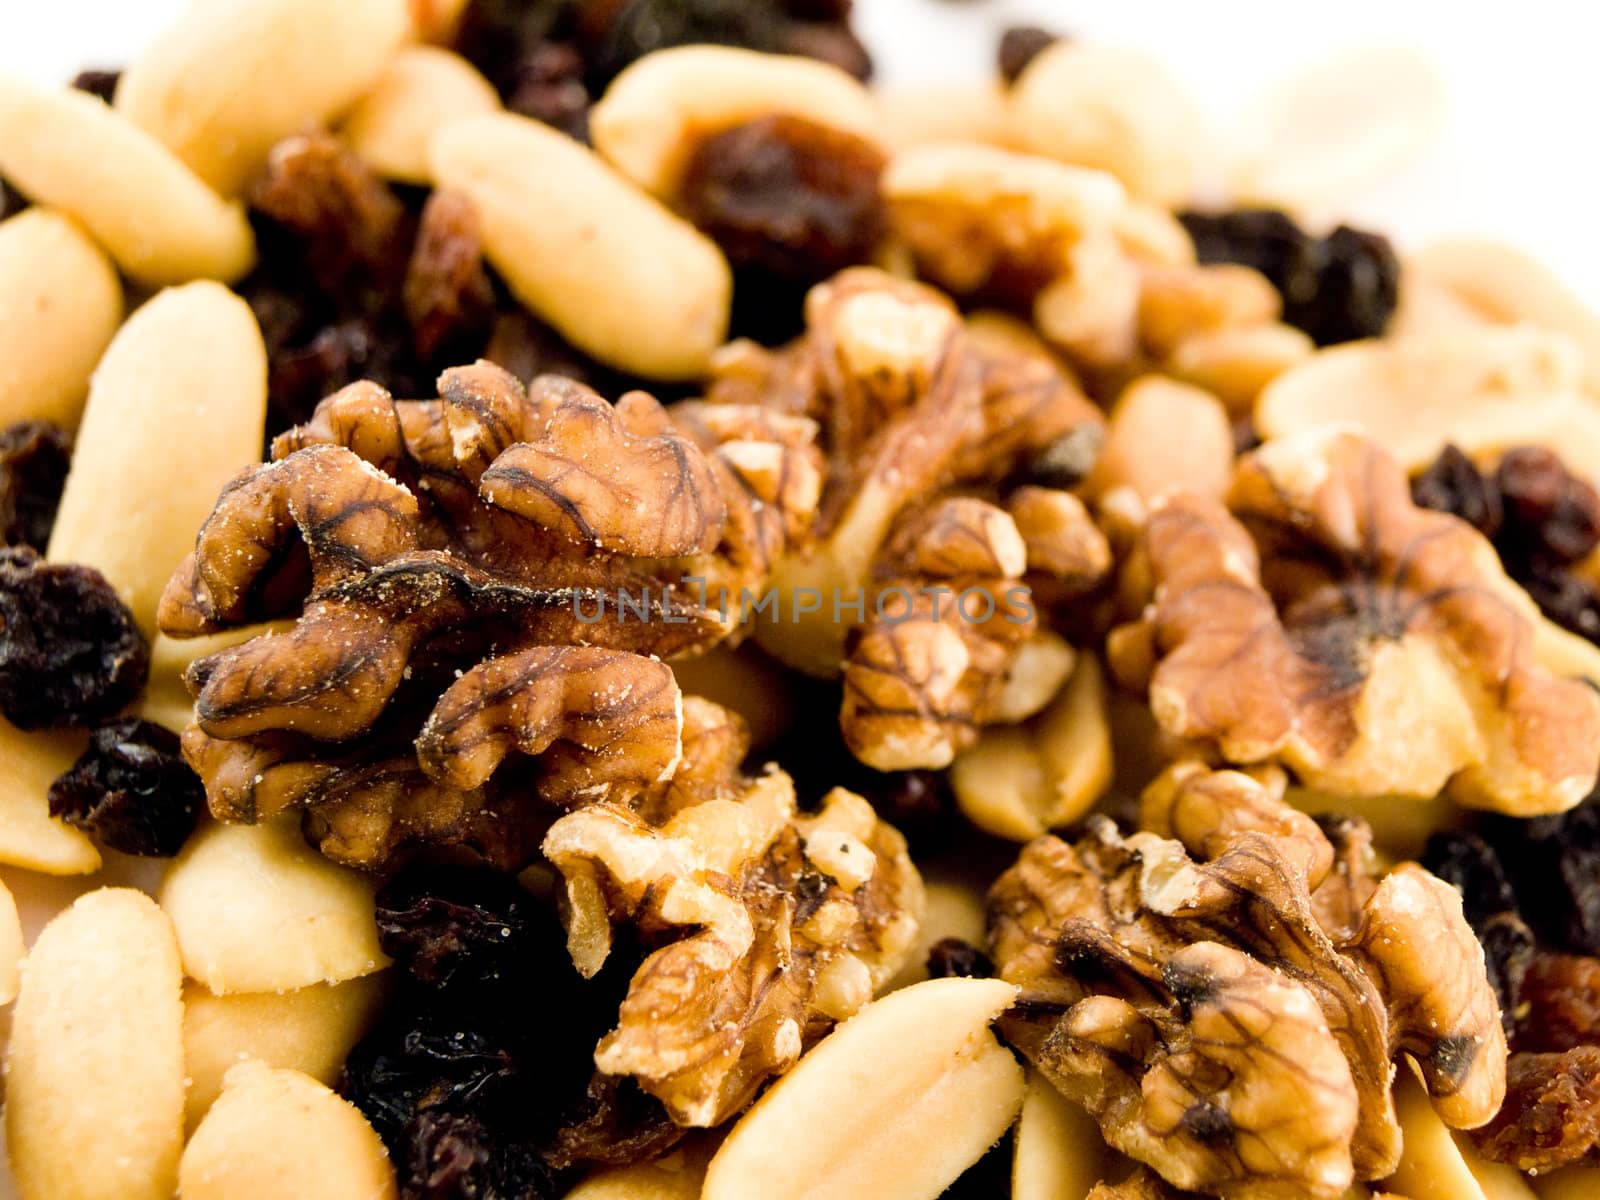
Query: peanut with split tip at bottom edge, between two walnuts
xmin=702 ymin=979 xmax=1022 ymax=1200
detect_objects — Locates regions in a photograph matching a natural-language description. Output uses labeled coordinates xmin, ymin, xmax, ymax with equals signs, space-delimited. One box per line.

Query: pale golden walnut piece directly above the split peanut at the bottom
xmin=544 ymin=770 xmax=922 ymax=1126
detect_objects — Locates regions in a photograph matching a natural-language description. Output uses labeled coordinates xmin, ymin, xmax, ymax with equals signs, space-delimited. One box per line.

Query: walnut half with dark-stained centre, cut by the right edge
xmin=1110 ymin=432 xmax=1600 ymax=816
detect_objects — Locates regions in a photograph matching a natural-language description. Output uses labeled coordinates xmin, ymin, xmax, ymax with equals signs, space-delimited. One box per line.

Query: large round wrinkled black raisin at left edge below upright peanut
xmin=0 ymin=547 xmax=150 ymax=730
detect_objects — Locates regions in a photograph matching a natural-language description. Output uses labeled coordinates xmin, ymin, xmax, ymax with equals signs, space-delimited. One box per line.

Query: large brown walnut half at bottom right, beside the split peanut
xmin=989 ymin=763 xmax=1506 ymax=1200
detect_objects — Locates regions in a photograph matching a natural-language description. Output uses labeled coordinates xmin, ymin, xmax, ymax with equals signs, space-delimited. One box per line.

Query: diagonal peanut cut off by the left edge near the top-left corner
xmin=0 ymin=75 xmax=256 ymax=286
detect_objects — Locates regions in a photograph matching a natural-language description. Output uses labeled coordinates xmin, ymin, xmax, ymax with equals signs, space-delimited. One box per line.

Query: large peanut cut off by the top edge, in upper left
xmin=117 ymin=0 xmax=411 ymax=195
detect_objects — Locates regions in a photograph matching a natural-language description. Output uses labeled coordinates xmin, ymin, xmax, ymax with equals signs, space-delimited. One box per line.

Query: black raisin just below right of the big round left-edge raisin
xmin=50 ymin=717 xmax=205 ymax=858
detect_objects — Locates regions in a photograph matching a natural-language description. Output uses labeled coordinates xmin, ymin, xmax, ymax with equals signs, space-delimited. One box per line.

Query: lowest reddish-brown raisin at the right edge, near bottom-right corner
xmin=1472 ymin=1046 xmax=1600 ymax=1171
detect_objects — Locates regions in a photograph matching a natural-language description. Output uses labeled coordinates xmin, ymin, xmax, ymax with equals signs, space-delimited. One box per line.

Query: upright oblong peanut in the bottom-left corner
xmin=5 ymin=888 xmax=184 ymax=1200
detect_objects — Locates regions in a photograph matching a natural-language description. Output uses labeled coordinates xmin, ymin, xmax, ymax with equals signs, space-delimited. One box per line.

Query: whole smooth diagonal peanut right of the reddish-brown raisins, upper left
xmin=429 ymin=114 xmax=733 ymax=379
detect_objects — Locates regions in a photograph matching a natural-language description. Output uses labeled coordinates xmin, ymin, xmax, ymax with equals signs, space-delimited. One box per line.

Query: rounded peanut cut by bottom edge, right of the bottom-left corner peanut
xmin=178 ymin=1061 xmax=395 ymax=1200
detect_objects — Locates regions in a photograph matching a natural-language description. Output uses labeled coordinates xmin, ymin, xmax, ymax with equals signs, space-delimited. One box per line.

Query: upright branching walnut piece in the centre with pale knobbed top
xmin=707 ymin=269 xmax=1109 ymax=770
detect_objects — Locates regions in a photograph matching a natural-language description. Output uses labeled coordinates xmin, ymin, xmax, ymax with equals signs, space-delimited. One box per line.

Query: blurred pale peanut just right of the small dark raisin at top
xmin=1011 ymin=40 xmax=1203 ymax=206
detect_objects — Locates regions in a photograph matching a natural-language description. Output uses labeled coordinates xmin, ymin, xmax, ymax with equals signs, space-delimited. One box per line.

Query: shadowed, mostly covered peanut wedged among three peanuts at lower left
xmin=184 ymin=974 xmax=386 ymax=1130
